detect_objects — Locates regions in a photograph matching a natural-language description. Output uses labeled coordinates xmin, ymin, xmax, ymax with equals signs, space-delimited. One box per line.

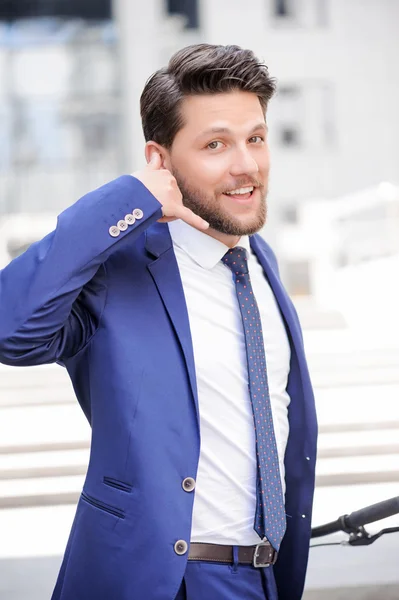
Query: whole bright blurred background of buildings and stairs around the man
xmin=0 ymin=0 xmax=399 ymax=600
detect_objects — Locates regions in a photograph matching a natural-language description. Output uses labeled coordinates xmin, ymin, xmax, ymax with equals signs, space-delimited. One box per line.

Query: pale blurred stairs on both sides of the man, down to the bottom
xmin=0 ymin=329 xmax=399 ymax=600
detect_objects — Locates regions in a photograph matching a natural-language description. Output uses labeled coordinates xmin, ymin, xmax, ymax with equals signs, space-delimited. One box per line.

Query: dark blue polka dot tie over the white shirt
xmin=222 ymin=247 xmax=286 ymax=550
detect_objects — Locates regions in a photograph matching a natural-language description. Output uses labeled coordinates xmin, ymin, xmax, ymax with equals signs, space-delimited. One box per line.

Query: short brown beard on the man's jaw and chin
xmin=172 ymin=169 xmax=267 ymax=236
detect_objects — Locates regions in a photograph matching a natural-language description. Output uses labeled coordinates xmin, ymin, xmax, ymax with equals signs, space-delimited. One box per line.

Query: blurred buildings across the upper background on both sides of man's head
xmin=0 ymin=0 xmax=399 ymax=295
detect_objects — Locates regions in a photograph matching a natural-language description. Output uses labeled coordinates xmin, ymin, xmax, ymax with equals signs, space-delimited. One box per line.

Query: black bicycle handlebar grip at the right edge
xmin=311 ymin=496 xmax=399 ymax=538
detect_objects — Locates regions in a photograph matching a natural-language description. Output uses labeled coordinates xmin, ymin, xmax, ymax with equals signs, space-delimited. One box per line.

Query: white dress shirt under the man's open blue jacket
xmin=169 ymin=220 xmax=290 ymax=546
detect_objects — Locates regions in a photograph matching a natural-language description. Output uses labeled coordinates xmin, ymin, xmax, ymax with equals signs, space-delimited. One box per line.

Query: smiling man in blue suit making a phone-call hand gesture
xmin=0 ymin=44 xmax=316 ymax=600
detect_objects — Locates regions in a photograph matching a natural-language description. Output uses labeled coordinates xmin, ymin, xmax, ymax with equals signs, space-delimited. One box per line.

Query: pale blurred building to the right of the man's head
xmin=200 ymin=0 xmax=399 ymax=293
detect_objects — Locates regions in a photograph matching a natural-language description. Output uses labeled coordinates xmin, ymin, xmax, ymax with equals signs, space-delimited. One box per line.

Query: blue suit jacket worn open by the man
xmin=0 ymin=176 xmax=316 ymax=600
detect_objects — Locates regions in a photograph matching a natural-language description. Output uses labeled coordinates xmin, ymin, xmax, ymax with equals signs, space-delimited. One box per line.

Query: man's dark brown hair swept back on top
xmin=140 ymin=44 xmax=275 ymax=148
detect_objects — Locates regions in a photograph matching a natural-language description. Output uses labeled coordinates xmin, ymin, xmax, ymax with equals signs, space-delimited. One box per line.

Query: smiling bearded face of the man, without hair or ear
xmin=165 ymin=91 xmax=269 ymax=236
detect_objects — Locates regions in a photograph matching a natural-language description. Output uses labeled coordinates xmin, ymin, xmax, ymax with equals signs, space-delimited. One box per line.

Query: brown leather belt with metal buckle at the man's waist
xmin=188 ymin=541 xmax=277 ymax=568
